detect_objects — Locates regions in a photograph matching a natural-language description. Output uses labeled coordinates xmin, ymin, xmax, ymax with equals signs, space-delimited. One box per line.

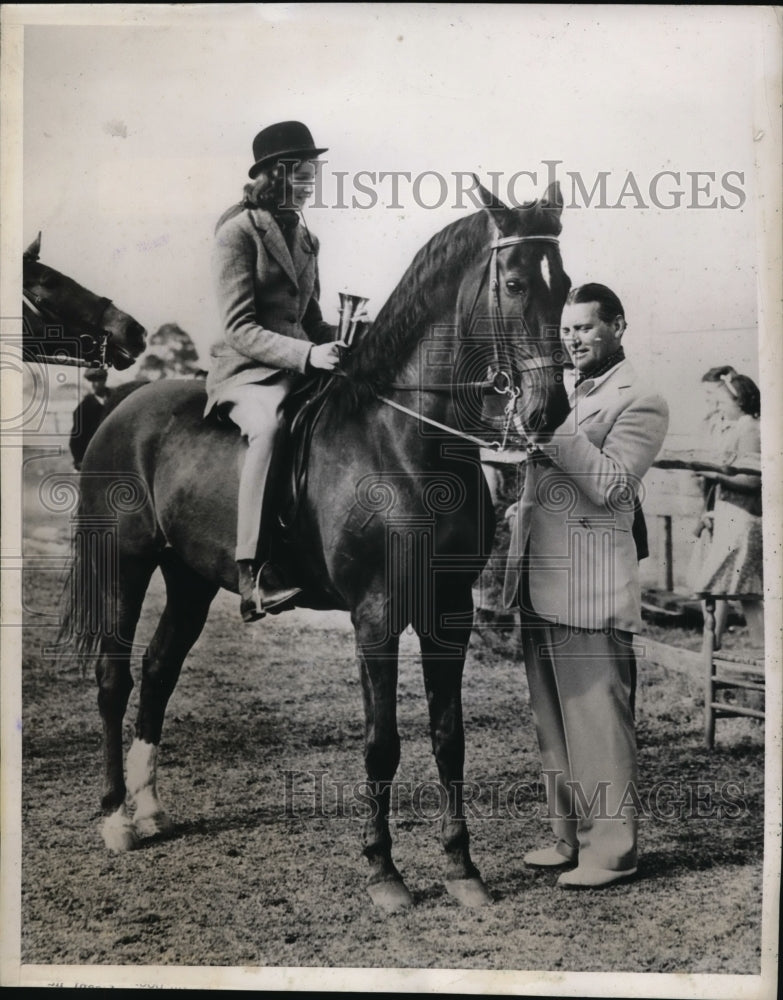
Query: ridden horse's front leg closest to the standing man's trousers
xmin=414 ymin=591 xmax=492 ymax=906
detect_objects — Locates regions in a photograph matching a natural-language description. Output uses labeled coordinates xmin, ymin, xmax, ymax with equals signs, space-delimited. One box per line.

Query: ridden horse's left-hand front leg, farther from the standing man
xmin=354 ymin=619 xmax=413 ymax=912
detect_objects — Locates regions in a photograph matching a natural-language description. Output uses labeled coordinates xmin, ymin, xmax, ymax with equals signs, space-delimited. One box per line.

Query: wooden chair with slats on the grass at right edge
xmin=697 ymin=593 xmax=765 ymax=750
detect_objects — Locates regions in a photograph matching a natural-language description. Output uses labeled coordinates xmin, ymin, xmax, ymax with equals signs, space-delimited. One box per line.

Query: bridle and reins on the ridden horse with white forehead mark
xmin=376 ymin=236 xmax=560 ymax=452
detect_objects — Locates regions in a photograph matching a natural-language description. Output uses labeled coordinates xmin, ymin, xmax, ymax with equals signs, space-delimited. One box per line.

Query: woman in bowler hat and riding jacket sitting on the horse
xmin=206 ymin=122 xmax=348 ymax=622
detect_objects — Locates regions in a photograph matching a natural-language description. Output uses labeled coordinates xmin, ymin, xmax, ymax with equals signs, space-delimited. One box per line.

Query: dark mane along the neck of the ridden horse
xmin=340 ymin=211 xmax=490 ymax=403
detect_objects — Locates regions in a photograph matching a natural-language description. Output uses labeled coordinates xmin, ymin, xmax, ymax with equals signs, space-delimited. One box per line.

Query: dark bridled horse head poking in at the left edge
xmin=22 ymin=233 xmax=147 ymax=370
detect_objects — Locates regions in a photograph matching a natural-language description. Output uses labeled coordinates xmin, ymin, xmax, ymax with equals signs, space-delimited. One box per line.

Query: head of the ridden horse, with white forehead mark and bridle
xmin=462 ymin=182 xmax=571 ymax=431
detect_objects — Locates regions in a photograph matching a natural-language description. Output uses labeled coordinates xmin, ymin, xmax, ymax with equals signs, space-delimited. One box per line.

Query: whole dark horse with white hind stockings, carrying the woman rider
xmin=59 ymin=178 xmax=570 ymax=909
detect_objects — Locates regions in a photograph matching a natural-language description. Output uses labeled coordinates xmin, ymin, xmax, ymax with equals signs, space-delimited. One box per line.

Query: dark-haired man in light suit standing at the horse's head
xmin=505 ymin=284 xmax=668 ymax=889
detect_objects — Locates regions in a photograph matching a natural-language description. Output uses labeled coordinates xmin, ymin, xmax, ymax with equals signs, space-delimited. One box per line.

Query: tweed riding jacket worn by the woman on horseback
xmin=206 ymin=208 xmax=333 ymax=413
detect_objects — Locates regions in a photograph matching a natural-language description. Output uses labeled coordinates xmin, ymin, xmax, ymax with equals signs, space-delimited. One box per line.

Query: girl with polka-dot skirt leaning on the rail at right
xmin=696 ymin=368 xmax=764 ymax=648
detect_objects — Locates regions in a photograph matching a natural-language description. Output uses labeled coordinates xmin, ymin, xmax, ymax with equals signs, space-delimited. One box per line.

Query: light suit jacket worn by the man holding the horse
xmin=504 ymin=361 xmax=669 ymax=632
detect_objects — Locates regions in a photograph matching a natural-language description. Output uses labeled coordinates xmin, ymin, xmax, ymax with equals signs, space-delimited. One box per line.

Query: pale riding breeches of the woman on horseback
xmin=216 ymin=377 xmax=291 ymax=559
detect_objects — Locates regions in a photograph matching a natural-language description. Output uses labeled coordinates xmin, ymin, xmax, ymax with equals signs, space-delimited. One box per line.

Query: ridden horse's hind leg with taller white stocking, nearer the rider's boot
xmin=127 ymin=549 xmax=218 ymax=837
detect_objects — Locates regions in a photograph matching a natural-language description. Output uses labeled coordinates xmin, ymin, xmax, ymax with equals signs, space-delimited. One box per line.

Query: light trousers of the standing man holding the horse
xmin=522 ymin=611 xmax=638 ymax=871
